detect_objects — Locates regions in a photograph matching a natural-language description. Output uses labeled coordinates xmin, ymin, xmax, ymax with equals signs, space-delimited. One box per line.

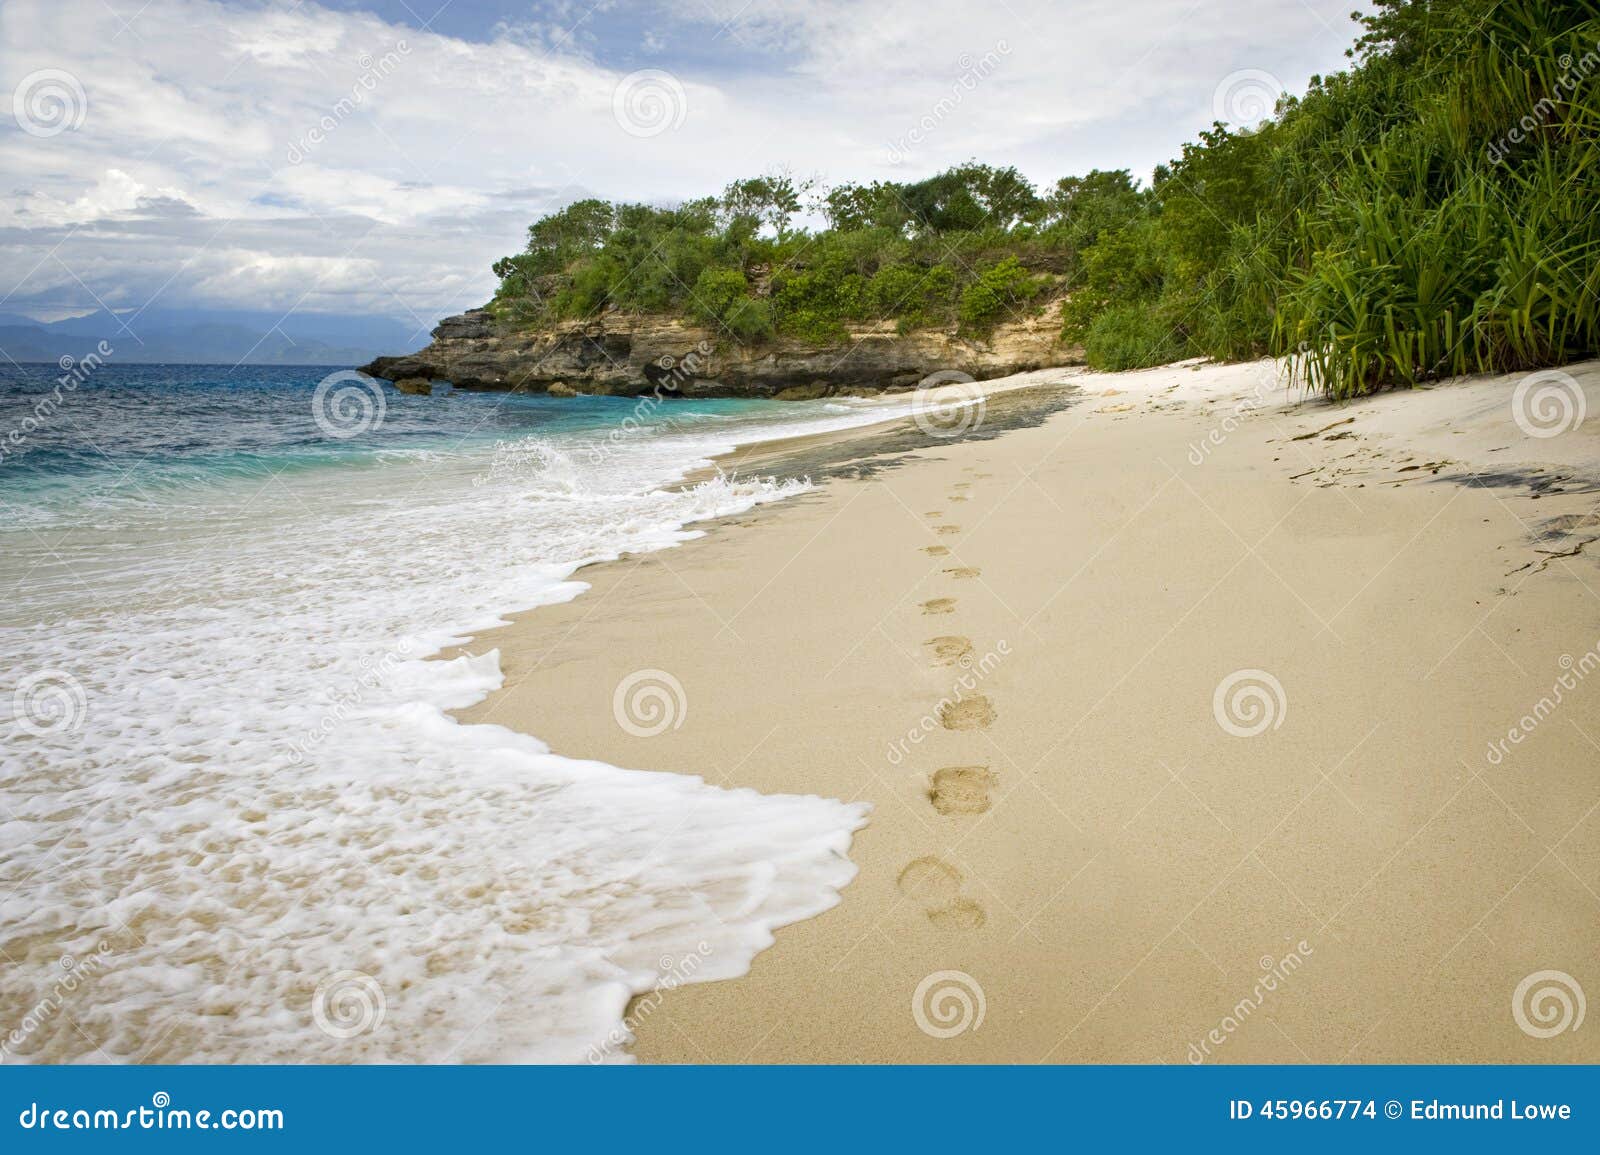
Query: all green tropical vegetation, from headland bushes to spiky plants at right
xmin=493 ymin=0 xmax=1600 ymax=397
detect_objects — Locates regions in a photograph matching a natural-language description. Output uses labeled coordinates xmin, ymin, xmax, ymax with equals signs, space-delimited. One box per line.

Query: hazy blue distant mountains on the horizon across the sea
xmin=0 ymin=309 xmax=427 ymax=365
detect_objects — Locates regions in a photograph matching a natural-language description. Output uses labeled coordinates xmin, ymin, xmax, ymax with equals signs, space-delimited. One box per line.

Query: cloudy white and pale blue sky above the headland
xmin=0 ymin=0 xmax=1376 ymax=342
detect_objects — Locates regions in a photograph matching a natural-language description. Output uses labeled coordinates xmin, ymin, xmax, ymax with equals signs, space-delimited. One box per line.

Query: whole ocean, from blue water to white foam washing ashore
xmin=0 ymin=362 xmax=910 ymax=1062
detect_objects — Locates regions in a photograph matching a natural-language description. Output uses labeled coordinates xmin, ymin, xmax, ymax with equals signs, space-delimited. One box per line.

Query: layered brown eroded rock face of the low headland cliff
xmin=365 ymin=302 xmax=1083 ymax=400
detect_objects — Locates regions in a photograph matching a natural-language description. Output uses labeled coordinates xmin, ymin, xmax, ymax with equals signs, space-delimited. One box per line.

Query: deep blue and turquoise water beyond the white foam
xmin=0 ymin=365 xmax=814 ymax=504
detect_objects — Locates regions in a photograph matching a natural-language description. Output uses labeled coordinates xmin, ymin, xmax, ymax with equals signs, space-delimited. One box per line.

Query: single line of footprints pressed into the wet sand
xmin=898 ymin=469 xmax=998 ymax=929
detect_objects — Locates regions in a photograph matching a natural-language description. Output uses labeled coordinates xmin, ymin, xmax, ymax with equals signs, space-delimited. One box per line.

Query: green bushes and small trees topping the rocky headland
xmin=491 ymin=163 xmax=1062 ymax=342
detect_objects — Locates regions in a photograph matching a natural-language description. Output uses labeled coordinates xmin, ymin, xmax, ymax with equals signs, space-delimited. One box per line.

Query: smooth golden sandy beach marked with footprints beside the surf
xmin=461 ymin=363 xmax=1600 ymax=1062
